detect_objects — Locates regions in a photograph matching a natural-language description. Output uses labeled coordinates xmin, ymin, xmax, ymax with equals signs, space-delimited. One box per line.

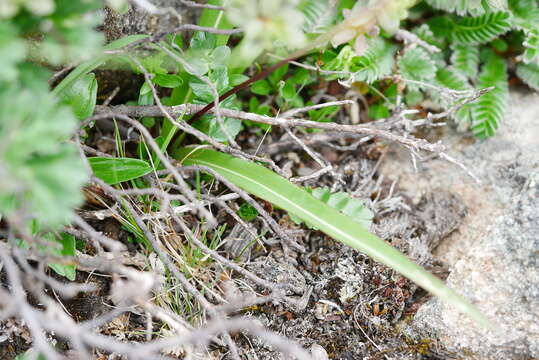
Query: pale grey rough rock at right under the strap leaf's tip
xmin=383 ymin=92 xmax=539 ymax=360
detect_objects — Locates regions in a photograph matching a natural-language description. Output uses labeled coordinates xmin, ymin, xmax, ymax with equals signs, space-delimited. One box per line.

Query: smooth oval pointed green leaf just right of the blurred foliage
xmin=88 ymin=156 xmax=152 ymax=185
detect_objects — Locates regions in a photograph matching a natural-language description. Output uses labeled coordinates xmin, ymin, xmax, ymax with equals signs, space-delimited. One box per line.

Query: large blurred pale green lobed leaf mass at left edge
xmin=0 ymin=79 xmax=87 ymax=226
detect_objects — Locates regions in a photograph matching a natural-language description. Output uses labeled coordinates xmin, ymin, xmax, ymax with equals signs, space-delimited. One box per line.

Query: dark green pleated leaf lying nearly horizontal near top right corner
xmin=452 ymin=11 xmax=511 ymax=45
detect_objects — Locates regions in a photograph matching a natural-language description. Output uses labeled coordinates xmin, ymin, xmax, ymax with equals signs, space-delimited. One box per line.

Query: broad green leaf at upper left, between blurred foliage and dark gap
xmin=61 ymin=73 xmax=97 ymax=120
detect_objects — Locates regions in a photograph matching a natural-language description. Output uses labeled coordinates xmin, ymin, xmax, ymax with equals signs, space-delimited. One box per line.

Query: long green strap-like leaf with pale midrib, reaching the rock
xmin=174 ymin=148 xmax=490 ymax=327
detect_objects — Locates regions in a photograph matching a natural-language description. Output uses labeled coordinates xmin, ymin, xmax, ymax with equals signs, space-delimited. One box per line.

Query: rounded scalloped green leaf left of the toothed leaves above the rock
xmin=398 ymin=47 xmax=436 ymax=89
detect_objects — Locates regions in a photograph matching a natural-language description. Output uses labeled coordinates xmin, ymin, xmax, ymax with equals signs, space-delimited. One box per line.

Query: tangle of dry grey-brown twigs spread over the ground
xmin=0 ymin=0 xmax=490 ymax=360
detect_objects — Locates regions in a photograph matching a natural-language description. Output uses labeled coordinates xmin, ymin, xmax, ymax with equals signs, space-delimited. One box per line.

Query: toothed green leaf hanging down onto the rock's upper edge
xmin=471 ymin=55 xmax=509 ymax=139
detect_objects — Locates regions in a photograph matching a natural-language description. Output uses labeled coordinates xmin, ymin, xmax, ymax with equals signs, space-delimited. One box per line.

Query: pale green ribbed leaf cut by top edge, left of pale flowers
xmin=298 ymin=0 xmax=337 ymax=34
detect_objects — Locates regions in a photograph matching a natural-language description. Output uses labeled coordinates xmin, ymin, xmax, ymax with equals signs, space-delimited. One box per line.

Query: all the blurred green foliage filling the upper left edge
xmin=0 ymin=0 xmax=111 ymax=286
